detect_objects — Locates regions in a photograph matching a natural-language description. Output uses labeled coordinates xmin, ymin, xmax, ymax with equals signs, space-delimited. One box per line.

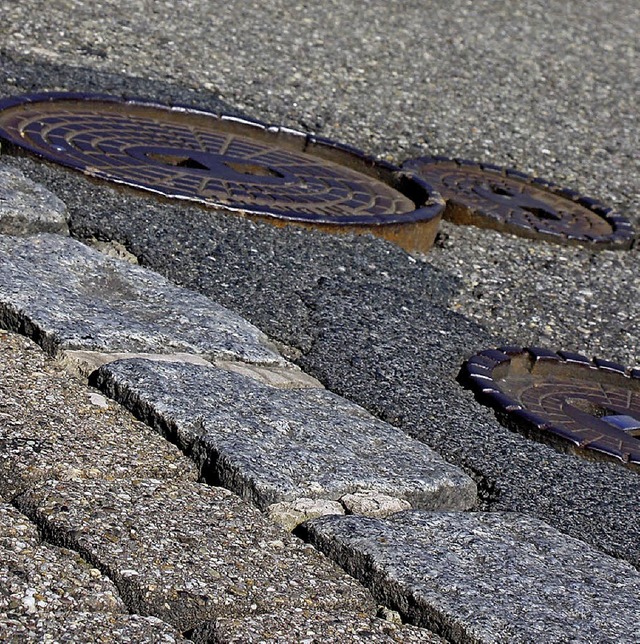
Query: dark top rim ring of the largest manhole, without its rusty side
xmin=0 ymin=92 xmax=444 ymax=234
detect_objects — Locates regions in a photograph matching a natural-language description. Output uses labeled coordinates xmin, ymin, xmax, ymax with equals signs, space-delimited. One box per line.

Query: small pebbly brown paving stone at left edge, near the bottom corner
xmin=0 ymin=504 xmax=126 ymax=620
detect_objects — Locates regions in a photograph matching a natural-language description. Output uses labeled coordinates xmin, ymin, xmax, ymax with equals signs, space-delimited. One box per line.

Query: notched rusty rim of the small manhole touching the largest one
xmin=402 ymin=156 xmax=635 ymax=250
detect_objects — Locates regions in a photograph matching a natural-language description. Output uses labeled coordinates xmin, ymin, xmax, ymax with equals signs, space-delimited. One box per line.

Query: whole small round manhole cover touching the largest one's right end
xmin=402 ymin=157 xmax=634 ymax=249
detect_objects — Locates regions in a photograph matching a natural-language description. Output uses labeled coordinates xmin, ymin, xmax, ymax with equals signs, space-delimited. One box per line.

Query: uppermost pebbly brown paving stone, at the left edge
xmin=0 ymin=332 xmax=198 ymax=499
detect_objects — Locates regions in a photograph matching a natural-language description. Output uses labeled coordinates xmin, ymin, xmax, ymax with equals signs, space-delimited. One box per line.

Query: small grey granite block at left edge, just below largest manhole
xmin=0 ymin=166 xmax=69 ymax=235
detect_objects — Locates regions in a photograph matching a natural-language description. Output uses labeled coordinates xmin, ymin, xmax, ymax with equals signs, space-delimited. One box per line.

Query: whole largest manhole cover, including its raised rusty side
xmin=0 ymin=93 xmax=444 ymax=251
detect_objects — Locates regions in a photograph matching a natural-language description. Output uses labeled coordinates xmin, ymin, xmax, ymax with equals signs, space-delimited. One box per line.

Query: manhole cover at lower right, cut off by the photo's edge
xmin=459 ymin=347 xmax=640 ymax=467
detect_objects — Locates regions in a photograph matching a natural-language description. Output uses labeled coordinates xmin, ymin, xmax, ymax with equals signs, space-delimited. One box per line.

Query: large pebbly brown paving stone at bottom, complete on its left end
xmin=16 ymin=480 xmax=382 ymax=632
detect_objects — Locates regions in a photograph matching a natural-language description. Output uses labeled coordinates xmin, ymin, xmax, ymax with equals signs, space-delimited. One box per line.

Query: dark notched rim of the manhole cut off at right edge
xmin=458 ymin=346 xmax=640 ymax=471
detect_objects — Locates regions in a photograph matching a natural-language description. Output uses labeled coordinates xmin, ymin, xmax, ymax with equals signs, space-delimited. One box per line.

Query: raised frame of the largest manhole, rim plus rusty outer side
xmin=0 ymin=92 xmax=444 ymax=250
